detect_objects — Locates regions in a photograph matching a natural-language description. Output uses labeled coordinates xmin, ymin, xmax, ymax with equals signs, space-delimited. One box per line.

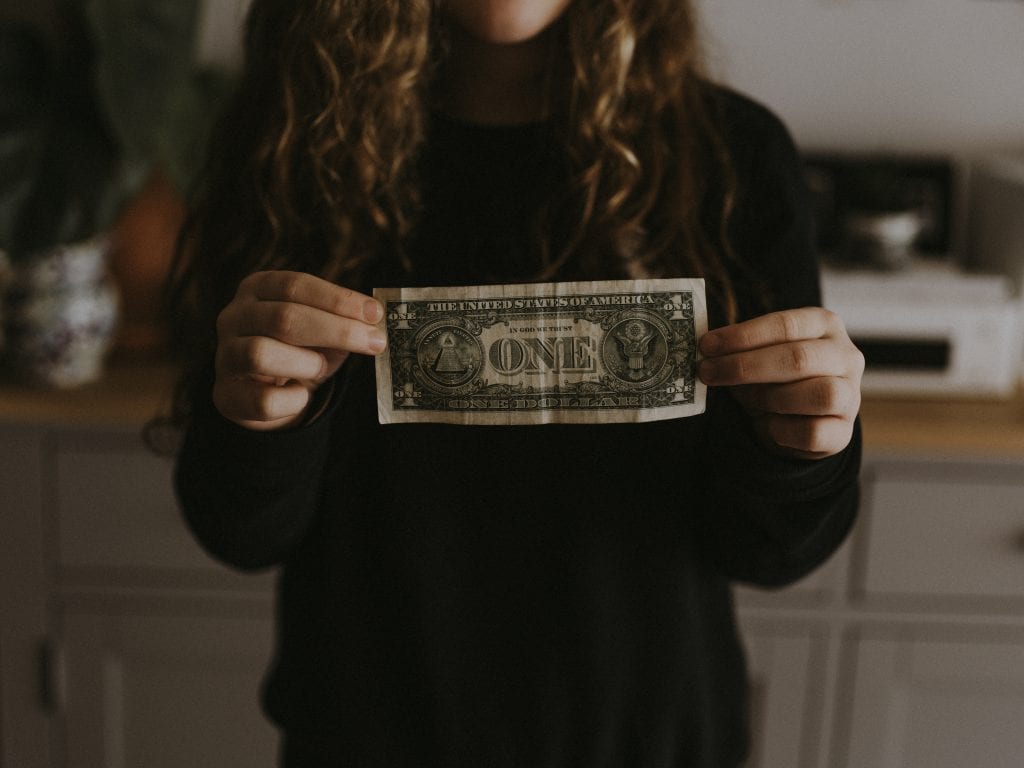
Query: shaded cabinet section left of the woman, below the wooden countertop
xmin=0 ymin=427 xmax=278 ymax=768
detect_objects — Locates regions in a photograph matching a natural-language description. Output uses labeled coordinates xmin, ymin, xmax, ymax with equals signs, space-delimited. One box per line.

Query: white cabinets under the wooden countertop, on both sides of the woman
xmin=0 ymin=411 xmax=1024 ymax=768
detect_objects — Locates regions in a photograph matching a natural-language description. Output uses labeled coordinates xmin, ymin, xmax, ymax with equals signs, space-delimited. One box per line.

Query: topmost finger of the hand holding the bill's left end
xmin=239 ymin=270 xmax=384 ymax=325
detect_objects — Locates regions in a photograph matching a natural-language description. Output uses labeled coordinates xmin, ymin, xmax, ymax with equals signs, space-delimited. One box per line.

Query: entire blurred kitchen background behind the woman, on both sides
xmin=0 ymin=0 xmax=1024 ymax=768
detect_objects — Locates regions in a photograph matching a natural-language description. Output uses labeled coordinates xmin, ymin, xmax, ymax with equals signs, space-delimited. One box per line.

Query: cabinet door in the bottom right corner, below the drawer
xmin=831 ymin=628 xmax=1024 ymax=768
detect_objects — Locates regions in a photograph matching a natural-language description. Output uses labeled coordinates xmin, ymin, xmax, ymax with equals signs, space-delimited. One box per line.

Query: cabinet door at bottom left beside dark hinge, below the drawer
xmin=63 ymin=607 xmax=278 ymax=768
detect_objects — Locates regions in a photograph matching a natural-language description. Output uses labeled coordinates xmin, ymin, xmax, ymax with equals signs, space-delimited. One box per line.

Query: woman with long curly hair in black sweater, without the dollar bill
xmin=167 ymin=0 xmax=863 ymax=768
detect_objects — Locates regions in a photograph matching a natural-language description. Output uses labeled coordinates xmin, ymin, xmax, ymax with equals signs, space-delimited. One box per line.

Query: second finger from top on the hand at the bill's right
xmin=699 ymin=339 xmax=853 ymax=386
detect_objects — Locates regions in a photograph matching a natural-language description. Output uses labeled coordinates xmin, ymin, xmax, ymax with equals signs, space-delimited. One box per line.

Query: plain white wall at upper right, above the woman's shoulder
xmin=697 ymin=0 xmax=1024 ymax=155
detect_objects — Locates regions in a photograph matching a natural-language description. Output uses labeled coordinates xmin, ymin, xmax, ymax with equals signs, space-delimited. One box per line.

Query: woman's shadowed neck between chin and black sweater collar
xmin=438 ymin=25 xmax=554 ymax=125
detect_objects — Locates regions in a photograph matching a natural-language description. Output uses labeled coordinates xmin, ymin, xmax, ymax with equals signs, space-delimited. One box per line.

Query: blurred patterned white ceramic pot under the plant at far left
xmin=4 ymin=238 xmax=120 ymax=388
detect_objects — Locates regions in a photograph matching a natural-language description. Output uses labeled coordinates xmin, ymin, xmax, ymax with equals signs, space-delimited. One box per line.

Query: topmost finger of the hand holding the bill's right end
xmin=700 ymin=307 xmax=846 ymax=357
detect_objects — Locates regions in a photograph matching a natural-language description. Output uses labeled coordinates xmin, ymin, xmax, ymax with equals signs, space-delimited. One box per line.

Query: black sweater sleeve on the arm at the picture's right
xmin=698 ymin=94 xmax=861 ymax=586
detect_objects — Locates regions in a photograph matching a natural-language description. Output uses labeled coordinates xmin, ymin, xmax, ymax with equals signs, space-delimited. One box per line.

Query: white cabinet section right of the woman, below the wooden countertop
xmin=738 ymin=458 xmax=1024 ymax=768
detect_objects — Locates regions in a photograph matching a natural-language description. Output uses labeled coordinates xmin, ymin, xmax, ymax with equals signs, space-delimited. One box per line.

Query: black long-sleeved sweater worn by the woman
xmin=176 ymin=88 xmax=860 ymax=768
